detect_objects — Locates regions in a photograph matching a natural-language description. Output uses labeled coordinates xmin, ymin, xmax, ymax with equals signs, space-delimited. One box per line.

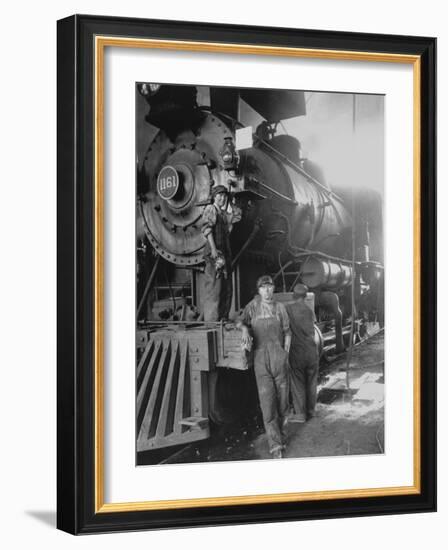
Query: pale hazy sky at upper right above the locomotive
xmin=241 ymin=92 xmax=384 ymax=198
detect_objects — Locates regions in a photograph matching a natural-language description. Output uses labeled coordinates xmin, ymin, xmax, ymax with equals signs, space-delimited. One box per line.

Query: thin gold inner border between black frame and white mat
xmin=94 ymin=36 xmax=421 ymax=513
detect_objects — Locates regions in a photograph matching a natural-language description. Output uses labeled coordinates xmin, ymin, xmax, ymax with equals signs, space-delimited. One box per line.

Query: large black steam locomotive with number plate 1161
xmin=136 ymin=83 xmax=384 ymax=451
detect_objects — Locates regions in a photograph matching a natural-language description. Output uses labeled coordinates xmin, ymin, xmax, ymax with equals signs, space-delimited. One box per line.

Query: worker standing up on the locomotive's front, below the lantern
xmin=202 ymin=185 xmax=232 ymax=321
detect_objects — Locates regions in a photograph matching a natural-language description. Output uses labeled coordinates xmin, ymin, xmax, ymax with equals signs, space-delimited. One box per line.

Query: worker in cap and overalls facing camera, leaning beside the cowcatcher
xmin=238 ymin=275 xmax=291 ymax=458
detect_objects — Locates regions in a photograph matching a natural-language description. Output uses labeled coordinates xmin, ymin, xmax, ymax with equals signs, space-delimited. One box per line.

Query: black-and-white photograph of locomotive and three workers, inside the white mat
xmin=135 ymin=82 xmax=388 ymax=466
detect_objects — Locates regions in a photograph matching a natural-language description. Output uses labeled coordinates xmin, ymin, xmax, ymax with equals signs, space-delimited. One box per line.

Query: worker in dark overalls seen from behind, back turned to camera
xmin=286 ymin=284 xmax=319 ymax=422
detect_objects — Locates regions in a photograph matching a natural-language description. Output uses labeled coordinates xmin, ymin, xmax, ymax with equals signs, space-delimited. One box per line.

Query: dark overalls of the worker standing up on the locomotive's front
xmin=203 ymin=205 xmax=232 ymax=321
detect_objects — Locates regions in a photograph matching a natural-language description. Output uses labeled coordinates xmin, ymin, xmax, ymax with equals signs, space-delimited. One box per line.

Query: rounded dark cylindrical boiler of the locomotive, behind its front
xmin=226 ymin=135 xmax=352 ymax=261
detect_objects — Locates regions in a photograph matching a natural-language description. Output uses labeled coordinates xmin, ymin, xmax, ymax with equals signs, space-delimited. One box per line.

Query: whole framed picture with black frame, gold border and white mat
xmin=57 ymin=15 xmax=436 ymax=534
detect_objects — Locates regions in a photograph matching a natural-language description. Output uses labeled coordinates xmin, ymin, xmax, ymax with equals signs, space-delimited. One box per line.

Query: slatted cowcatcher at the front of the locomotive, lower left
xmin=136 ymin=329 xmax=215 ymax=452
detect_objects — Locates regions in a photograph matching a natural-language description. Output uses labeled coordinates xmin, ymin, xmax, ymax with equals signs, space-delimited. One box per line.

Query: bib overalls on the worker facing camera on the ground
xmin=251 ymin=306 xmax=289 ymax=452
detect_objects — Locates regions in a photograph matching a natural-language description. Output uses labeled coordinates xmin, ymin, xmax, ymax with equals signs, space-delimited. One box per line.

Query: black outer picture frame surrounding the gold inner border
xmin=57 ymin=15 xmax=436 ymax=534
